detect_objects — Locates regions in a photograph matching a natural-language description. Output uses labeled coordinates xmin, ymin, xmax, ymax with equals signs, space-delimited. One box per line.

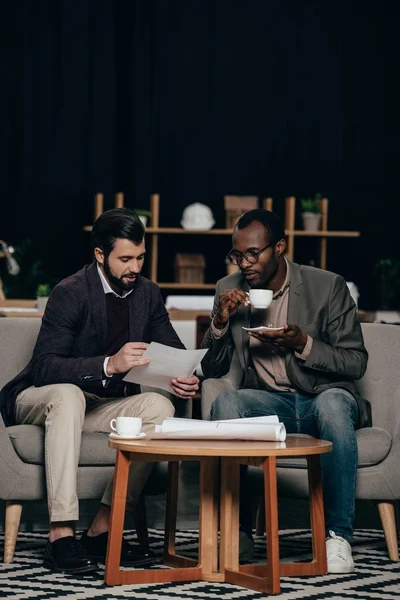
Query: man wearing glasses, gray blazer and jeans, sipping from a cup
xmin=202 ymin=209 xmax=370 ymax=573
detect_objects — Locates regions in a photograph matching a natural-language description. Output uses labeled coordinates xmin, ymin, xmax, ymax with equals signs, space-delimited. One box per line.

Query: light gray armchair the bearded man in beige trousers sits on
xmin=0 ymin=318 xmax=191 ymax=563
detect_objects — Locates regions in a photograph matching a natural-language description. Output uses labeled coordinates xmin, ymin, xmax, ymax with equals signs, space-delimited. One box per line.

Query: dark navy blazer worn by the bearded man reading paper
xmin=0 ymin=262 xmax=184 ymax=425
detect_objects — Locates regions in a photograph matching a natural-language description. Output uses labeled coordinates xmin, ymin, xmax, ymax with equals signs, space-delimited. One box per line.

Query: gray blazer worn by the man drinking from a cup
xmin=202 ymin=261 xmax=371 ymax=427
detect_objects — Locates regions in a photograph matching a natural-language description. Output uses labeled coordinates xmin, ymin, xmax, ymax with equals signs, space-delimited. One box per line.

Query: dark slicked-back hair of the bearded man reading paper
xmin=91 ymin=208 xmax=144 ymax=257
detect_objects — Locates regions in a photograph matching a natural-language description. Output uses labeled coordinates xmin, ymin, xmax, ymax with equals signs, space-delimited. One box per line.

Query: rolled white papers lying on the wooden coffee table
xmin=150 ymin=415 xmax=286 ymax=442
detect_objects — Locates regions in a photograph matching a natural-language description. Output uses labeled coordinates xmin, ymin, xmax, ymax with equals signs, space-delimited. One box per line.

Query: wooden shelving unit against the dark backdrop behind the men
xmin=83 ymin=192 xmax=360 ymax=290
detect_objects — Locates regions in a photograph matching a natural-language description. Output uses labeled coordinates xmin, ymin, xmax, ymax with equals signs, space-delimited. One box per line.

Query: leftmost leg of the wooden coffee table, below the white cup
xmin=104 ymin=450 xmax=130 ymax=585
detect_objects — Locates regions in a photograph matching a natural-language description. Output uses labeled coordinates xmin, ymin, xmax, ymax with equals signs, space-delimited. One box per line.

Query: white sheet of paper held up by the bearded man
xmin=124 ymin=342 xmax=207 ymax=392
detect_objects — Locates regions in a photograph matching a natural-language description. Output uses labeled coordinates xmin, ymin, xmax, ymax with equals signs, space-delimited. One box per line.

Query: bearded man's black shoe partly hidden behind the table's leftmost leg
xmin=80 ymin=531 xmax=154 ymax=567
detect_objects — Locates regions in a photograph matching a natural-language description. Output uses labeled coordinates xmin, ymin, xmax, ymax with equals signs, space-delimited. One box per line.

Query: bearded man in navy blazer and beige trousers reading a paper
xmin=0 ymin=208 xmax=198 ymax=573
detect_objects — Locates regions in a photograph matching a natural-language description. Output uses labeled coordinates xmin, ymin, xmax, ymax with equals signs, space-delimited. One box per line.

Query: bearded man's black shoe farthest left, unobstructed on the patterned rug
xmin=43 ymin=535 xmax=98 ymax=573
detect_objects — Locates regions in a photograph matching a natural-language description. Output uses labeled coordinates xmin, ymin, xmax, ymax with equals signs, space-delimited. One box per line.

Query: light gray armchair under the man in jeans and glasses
xmin=202 ymin=323 xmax=400 ymax=561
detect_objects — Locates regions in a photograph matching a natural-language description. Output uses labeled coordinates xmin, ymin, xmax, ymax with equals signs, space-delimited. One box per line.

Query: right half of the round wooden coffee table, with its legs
xmin=220 ymin=436 xmax=332 ymax=594
